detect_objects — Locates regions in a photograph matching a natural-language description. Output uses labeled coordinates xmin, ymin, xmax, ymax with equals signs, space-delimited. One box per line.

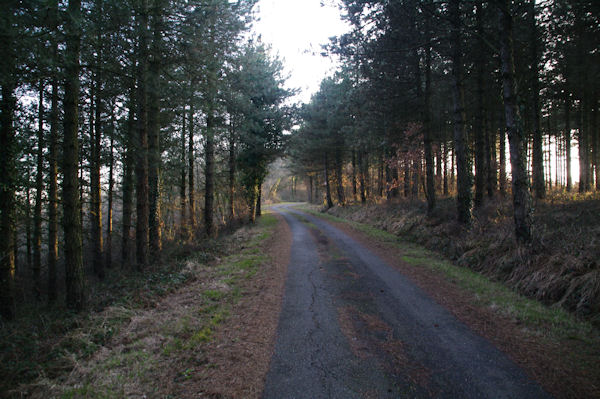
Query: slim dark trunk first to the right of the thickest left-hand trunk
xmin=90 ymin=76 xmax=104 ymax=279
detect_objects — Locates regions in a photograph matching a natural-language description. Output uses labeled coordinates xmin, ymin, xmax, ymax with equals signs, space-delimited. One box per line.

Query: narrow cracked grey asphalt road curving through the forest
xmin=263 ymin=205 xmax=550 ymax=399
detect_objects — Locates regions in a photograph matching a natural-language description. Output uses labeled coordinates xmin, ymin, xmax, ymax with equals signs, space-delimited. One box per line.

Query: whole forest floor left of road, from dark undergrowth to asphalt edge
xmin=0 ymin=214 xmax=290 ymax=398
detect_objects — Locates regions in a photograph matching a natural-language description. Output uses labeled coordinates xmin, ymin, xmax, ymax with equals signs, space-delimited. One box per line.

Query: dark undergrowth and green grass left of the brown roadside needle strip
xmin=0 ymin=215 xmax=276 ymax=398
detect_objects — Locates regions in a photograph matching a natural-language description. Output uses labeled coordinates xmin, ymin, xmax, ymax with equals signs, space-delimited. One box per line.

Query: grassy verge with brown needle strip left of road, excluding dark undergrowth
xmin=8 ymin=215 xmax=291 ymax=398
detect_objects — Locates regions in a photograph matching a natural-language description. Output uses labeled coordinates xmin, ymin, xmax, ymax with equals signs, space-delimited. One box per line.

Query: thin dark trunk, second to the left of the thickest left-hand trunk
xmin=33 ymin=81 xmax=44 ymax=300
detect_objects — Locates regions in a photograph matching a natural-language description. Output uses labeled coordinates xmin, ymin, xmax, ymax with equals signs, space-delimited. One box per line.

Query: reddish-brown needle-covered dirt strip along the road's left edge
xmin=177 ymin=215 xmax=292 ymax=398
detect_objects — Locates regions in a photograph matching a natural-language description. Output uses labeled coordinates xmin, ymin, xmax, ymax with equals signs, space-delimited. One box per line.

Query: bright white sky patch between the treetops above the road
xmin=254 ymin=0 xmax=348 ymax=102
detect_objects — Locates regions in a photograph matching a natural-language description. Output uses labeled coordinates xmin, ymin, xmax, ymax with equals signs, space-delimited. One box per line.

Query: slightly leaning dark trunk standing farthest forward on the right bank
xmin=498 ymin=0 xmax=532 ymax=242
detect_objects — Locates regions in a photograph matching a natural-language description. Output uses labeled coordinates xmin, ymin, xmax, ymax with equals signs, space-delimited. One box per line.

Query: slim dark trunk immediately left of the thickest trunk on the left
xmin=48 ymin=44 xmax=59 ymax=303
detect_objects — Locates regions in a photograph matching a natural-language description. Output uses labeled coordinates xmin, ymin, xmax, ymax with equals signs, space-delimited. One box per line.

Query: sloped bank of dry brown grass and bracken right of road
xmin=327 ymin=198 xmax=600 ymax=327
